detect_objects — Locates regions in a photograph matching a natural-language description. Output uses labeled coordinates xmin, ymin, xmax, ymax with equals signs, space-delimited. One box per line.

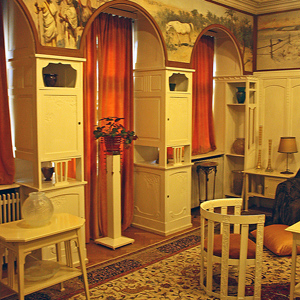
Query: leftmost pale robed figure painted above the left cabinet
xmin=34 ymin=0 xmax=58 ymax=47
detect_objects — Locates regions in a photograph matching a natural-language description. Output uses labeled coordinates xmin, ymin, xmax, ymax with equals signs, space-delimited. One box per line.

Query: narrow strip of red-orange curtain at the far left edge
xmin=0 ymin=2 xmax=15 ymax=184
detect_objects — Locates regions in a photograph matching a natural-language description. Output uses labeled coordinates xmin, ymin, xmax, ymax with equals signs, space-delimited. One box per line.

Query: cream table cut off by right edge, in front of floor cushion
xmin=285 ymin=222 xmax=300 ymax=300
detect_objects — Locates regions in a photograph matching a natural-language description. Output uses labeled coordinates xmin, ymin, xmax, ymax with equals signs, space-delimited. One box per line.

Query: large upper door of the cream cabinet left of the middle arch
xmin=38 ymin=90 xmax=83 ymax=160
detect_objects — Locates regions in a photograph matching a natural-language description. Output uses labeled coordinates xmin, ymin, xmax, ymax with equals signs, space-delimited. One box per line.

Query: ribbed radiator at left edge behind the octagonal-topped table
xmin=0 ymin=191 xmax=21 ymax=267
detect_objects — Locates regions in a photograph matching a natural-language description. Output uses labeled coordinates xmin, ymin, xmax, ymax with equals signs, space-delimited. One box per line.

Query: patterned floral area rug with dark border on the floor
xmin=2 ymin=230 xmax=300 ymax=300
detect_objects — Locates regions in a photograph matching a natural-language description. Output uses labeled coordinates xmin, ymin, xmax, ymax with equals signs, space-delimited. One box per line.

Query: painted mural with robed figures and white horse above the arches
xmin=23 ymin=0 xmax=253 ymax=72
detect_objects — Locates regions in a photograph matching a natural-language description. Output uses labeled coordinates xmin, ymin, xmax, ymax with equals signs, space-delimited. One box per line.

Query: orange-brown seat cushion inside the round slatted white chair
xmin=204 ymin=233 xmax=256 ymax=259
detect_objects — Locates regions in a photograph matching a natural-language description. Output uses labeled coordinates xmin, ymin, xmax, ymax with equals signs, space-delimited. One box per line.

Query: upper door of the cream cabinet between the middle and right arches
xmin=167 ymin=95 xmax=191 ymax=146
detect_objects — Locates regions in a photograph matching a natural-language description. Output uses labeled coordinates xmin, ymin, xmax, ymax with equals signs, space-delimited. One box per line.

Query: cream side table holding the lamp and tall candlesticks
xmin=244 ymin=169 xmax=296 ymax=210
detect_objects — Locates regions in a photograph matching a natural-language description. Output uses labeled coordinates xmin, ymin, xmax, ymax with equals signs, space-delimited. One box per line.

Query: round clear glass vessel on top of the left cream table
xmin=22 ymin=192 xmax=54 ymax=227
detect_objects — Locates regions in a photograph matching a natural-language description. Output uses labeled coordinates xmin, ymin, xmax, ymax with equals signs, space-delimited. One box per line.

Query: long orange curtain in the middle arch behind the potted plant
xmin=84 ymin=13 xmax=133 ymax=239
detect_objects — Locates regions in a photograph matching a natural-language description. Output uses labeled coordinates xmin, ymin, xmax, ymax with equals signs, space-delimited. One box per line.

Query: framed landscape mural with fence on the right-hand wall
xmin=257 ymin=10 xmax=300 ymax=70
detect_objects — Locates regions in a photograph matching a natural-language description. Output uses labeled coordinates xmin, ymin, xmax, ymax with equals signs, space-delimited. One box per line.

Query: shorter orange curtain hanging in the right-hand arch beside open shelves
xmin=192 ymin=36 xmax=216 ymax=155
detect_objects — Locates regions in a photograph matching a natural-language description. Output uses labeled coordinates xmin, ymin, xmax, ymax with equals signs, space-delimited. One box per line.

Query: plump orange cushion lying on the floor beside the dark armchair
xmin=251 ymin=224 xmax=300 ymax=256
